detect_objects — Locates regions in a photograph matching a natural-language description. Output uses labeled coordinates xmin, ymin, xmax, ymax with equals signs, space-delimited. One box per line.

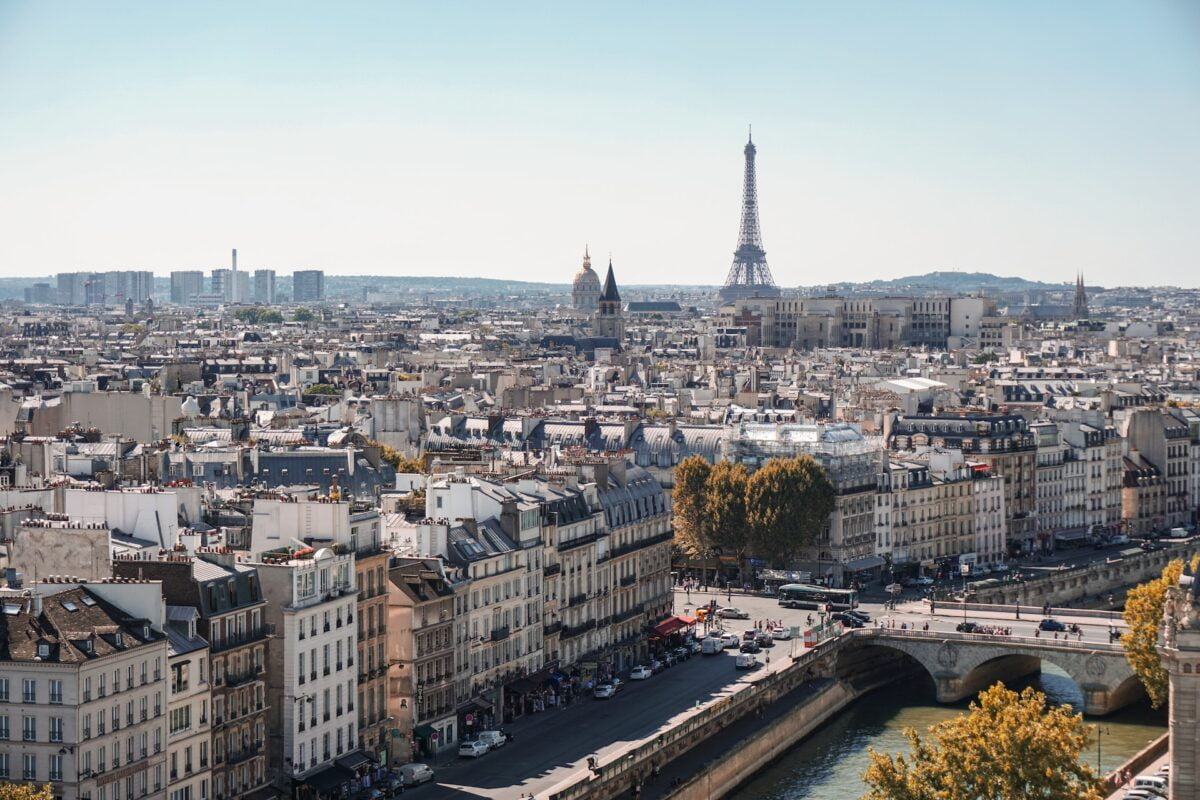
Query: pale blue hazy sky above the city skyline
xmin=0 ymin=0 xmax=1200 ymax=287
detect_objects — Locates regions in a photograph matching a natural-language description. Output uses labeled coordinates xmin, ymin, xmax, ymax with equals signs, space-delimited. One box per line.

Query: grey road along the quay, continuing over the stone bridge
xmin=412 ymin=589 xmax=1122 ymax=800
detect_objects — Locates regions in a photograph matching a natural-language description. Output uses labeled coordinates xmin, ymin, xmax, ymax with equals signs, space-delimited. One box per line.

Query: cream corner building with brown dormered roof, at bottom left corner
xmin=0 ymin=578 xmax=168 ymax=800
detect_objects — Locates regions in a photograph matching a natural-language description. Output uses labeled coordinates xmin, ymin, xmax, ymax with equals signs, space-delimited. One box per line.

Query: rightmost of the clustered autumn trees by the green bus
xmin=746 ymin=455 xmax=834 ymax=567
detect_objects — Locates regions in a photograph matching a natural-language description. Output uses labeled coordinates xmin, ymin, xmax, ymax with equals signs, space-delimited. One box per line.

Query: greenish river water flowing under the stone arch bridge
xmin=732 ymin=664 xmax=1166 ymax=800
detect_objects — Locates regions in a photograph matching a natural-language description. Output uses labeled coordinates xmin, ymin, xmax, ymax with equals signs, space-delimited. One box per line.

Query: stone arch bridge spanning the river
xmin=835 ymin=628 xmax=1142 ymax=716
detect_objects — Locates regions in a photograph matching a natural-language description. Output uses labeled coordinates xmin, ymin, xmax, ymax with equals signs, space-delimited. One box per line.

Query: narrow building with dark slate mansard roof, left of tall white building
xmin=113 ymin=548 xmax=270 ymax=800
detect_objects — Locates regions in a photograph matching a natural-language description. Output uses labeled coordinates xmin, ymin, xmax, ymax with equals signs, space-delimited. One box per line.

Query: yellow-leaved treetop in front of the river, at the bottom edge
xmin=862 ymin=684 xmax=1103 ymax=800
